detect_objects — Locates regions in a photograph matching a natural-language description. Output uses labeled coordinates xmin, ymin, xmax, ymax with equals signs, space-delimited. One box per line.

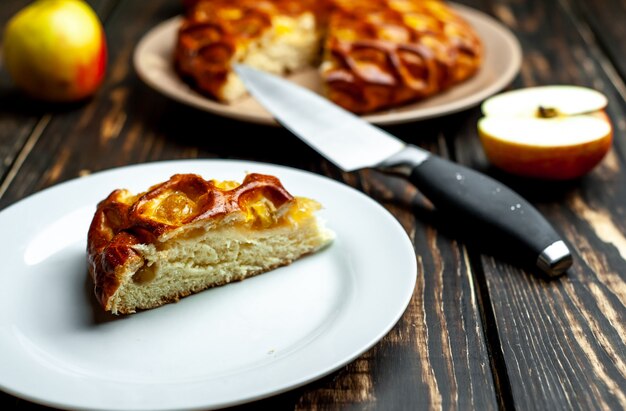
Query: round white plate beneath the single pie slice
xmin=0 ymin=160 xmax=417 ymax=410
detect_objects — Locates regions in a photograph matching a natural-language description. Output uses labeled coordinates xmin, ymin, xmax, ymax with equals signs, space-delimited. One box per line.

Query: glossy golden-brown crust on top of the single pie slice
xmin=87 ymin=174 xmax=295 ymax=312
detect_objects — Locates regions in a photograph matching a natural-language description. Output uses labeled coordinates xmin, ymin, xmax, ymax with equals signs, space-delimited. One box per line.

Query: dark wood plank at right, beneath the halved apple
xmin=450 ymin=0 xmax=626 ymax=409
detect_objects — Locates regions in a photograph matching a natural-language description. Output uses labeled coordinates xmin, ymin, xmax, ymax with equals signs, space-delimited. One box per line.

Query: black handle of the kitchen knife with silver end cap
xmin=384 ymin=146 xmax=572 ymax=276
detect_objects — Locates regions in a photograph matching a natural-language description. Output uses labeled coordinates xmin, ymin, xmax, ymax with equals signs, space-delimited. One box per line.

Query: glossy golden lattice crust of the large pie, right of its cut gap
xmin=321 ymin=0 xmax=482 ymax=113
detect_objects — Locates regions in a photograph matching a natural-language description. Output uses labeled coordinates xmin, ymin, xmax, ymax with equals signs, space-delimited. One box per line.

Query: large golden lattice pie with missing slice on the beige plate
xmin=175 ymin=0 xmax=483 ymax=113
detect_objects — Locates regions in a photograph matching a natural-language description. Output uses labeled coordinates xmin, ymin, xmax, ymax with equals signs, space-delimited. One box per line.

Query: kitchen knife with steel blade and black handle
xmin=235 ymin=65 xmax=572 ymax=276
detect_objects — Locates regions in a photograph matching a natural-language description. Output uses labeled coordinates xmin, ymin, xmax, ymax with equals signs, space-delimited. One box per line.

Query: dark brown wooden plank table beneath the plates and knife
xmin=0 ymin=0 xmax=626 ymax=410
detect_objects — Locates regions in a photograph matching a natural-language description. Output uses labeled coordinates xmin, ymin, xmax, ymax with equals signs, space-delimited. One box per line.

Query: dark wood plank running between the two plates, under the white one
xmin=0 ymin=0 xmax=497 ymax=409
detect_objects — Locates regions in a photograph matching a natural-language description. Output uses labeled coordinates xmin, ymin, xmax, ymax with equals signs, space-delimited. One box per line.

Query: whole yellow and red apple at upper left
xmin=4 ymin=0 xmax=107 ymax=102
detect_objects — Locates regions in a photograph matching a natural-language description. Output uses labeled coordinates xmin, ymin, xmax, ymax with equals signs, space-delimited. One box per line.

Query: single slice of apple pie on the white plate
xmin=87 ymin=174 xmax=333 ymax=314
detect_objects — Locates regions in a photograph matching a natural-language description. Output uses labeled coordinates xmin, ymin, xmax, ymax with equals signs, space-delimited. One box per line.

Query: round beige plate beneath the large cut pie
xmin=134 ymin=5 xmax=522 ymax=125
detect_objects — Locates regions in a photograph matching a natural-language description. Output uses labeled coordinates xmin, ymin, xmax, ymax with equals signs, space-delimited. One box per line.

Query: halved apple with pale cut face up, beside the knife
xmin=478 ymin=86 xmax=613 ymax=180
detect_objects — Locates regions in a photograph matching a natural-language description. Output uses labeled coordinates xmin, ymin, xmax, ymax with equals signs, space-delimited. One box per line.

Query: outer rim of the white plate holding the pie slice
xmin=0 ymin=159 xmax=417 ymax=410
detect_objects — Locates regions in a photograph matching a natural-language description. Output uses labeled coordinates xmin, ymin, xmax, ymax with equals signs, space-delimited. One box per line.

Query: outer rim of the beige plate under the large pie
xmin=132 ymin=2 xmax=522 ymax=127
